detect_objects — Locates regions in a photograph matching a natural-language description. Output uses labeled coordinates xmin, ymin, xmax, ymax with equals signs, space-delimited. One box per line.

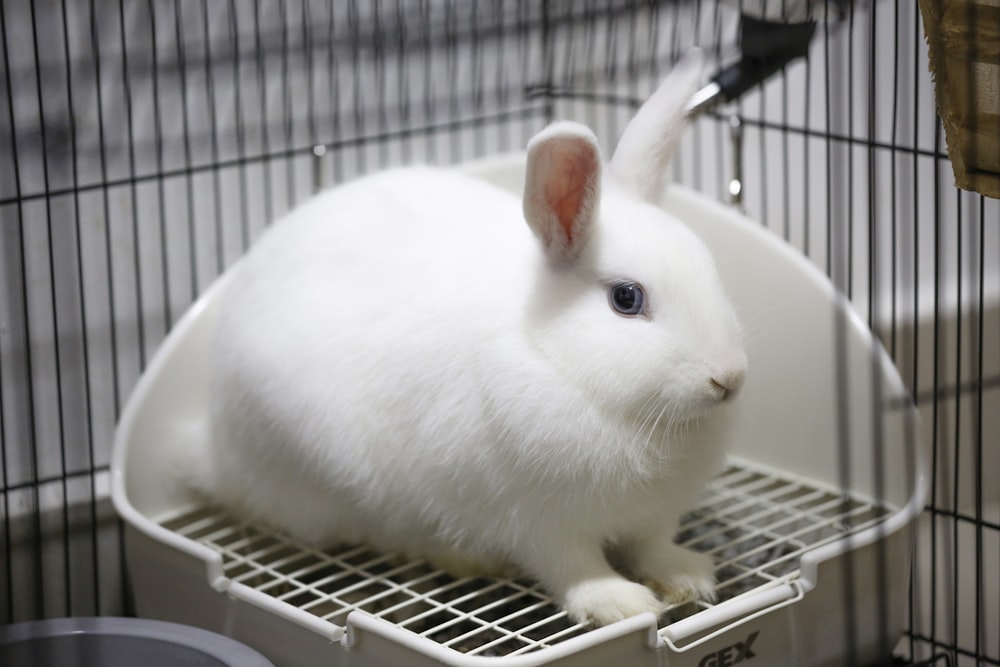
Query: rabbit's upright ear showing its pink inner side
xmin=524 ymin=122 xmax=602 ymax=264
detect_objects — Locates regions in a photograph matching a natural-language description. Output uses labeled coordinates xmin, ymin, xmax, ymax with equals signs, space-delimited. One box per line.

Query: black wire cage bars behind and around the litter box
xmin=0 ymin=0 xmax=1000 ymax=665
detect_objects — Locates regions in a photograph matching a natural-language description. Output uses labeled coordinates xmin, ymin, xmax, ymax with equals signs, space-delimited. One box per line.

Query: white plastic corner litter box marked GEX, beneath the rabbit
xmin=112 ymin=155 xmax=925 ymax=667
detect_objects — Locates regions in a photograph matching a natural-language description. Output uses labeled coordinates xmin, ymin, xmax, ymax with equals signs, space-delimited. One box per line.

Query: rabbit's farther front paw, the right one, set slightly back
xmin=639 ymin=544 xmax=715 ymax=605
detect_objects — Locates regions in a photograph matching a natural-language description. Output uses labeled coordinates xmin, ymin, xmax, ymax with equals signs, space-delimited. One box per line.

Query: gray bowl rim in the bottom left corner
xmin=0 ymin=617 xmax=274 ymax=667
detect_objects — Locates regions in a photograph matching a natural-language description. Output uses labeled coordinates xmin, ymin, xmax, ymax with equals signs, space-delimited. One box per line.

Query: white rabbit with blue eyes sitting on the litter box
xmin=187 ymin=51 xmax=746 ymax=624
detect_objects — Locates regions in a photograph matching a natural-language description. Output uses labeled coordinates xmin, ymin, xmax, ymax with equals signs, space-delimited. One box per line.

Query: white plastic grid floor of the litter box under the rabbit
xmin=161 ymin=462 xmax=893 ymax=656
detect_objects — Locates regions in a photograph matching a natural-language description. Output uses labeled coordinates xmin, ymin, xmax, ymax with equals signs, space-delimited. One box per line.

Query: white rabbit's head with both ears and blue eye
xmin=524 ymin=53 xmax=747 ymax=438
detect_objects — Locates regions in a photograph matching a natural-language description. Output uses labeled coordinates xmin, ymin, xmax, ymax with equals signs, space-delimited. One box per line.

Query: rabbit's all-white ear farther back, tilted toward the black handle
xmin=609 ymin=49 xmax=703 ymax=203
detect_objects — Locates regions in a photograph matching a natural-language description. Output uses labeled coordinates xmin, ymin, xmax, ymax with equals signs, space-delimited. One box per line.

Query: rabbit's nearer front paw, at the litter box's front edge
xmin=565 ymin=577 xmax=663 ymax=625
